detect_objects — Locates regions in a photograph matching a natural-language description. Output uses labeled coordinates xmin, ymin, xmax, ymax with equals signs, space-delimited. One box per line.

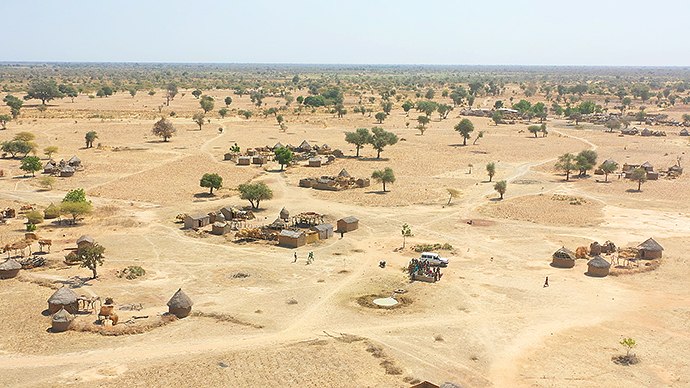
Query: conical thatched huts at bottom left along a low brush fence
xmin=48 ymin=286 xmax=194 ymax=333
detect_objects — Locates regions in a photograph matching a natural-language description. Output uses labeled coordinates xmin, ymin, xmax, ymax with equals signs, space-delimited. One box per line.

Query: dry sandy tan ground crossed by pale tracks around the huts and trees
xmin=0 ymin=91 xmax=690 ymax=387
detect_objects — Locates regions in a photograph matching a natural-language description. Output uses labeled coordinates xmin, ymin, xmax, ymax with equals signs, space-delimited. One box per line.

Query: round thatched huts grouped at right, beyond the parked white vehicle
xmin=551 ymin=237 xmax=664 ymax=277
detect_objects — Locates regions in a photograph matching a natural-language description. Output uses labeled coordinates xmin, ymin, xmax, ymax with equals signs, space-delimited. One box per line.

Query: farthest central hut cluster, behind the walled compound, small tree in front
xmin=223 ymin=140 xmax=343 ymax=167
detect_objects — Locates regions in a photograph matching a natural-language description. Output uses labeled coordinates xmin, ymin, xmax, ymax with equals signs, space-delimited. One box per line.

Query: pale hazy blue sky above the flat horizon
xmin=0 ymin=0 xmax=690 ymax=66
